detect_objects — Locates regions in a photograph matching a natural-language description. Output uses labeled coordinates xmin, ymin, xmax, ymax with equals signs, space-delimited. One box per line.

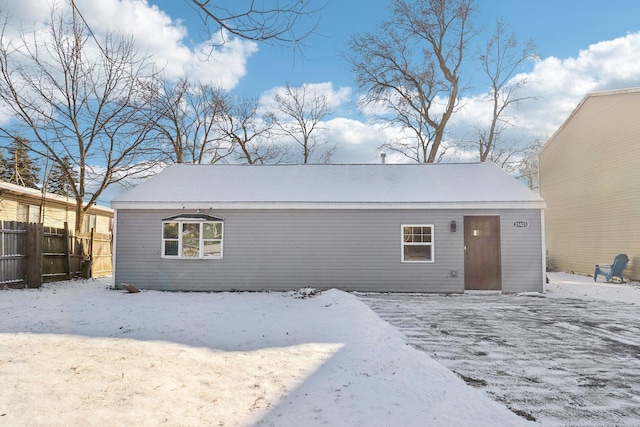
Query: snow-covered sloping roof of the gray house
xmin=111 ymin=163 xmax=545 ymax=209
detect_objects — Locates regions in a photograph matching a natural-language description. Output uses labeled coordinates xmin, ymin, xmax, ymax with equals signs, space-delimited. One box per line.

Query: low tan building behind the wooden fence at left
xmin=0 ymin=181 xmax=113 ymax=233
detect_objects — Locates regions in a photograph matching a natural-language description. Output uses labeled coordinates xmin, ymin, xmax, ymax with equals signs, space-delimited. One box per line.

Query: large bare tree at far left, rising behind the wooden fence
xmin=0 ymin=6 xmax=159 ymax=231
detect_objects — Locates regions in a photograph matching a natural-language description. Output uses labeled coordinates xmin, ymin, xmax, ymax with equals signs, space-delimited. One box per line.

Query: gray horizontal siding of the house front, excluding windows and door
xmin=115 ymin=209 xmax=542 ymax=292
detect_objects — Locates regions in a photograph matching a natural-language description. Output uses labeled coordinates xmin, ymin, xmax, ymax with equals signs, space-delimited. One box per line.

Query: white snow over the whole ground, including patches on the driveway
xmin=0 ymin=274 xmax=640 ymax=426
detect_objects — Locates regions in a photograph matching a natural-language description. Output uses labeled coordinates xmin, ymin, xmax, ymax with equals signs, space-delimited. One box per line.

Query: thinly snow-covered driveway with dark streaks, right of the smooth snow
xmin=359 ymin=273 xmax=640 ymax=426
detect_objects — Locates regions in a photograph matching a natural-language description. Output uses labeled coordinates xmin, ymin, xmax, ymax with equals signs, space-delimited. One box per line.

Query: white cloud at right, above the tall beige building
xmin=440 ymin=33 xmax=640 ymax=160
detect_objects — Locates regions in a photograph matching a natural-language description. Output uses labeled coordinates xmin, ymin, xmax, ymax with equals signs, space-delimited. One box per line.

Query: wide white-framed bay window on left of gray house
xmin=161 ymin=214 xmax=224 ymax=259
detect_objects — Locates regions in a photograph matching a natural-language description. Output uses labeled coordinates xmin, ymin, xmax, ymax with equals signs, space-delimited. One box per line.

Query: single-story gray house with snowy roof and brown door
xmin=112 ymin=163 xmax=545 ymax=293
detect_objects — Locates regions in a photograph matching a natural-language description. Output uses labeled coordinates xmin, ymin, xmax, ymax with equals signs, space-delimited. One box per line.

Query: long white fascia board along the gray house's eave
xmin=111 ymin=200 xmax=547 ymax=211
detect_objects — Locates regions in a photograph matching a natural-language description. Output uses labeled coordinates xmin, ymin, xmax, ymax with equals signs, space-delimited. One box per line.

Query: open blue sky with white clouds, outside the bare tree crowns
xmin=0 ymin=0 xmax=640 ymax=167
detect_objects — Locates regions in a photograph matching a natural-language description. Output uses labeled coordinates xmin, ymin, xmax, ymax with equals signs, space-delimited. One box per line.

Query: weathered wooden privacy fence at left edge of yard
xmin=0 ymin=222 xmax=112 ymax=288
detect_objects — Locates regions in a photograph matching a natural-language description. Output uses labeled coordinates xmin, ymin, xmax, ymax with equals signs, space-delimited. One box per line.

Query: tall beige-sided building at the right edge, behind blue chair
xmin=539 ymin=89 xmax=640 ymax=280
